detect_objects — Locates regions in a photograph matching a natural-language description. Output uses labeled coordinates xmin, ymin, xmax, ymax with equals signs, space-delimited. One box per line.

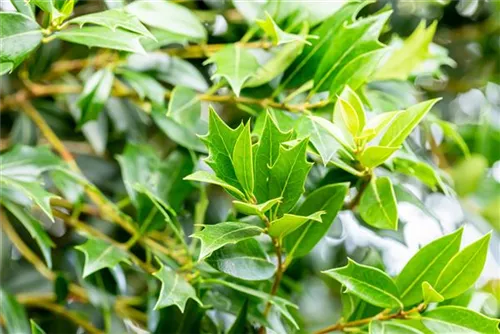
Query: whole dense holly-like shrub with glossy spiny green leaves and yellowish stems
xmin=0 ymin=0 xmax=499 ymax=334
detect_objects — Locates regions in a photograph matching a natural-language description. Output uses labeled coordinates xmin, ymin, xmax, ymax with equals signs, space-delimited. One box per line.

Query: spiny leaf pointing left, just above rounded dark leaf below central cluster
xmin=191 ymin=222 xmax=263 ymax=261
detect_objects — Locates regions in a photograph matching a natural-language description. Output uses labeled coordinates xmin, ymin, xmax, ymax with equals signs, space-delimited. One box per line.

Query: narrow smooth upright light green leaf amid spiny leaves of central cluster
xmin=233 ymin=122 xmax=254 ymax=198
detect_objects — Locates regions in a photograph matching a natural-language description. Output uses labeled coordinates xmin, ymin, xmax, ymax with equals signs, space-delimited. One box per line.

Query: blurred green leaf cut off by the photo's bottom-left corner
xmin=0 ymin=288 xmax=31 ymax=334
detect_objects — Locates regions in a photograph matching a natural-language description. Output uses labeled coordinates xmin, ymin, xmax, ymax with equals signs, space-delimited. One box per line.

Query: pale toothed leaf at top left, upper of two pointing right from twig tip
xmin=68 ymin=8 xmax=154 ymax=39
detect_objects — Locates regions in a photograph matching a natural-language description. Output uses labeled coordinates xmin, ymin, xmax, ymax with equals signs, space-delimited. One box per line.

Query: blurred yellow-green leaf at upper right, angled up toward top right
xmin=374 ymin=20 xmax=437 ymax=80
